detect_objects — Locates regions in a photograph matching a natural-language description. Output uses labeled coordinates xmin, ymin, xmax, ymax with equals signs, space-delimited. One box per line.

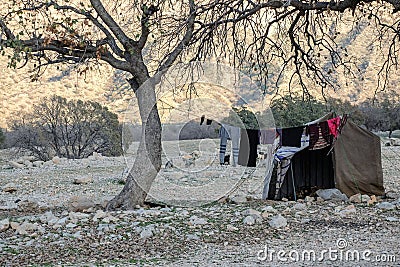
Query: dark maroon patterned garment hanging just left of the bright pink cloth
xmin=307 ymin=121 xmax=332 ymax=150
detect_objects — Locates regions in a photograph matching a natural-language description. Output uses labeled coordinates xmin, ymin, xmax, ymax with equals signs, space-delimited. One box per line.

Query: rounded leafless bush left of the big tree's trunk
xmin=11 ymin=96 xmax=122 ymax=160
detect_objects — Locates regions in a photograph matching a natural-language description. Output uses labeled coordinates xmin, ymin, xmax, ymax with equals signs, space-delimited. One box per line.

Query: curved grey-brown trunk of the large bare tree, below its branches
xmin=106 ymin=77 xmax=162 ymax=210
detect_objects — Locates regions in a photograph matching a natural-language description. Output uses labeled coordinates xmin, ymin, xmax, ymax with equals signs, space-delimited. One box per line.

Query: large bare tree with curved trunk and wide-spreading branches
xmin=0 ymin=0 xmax=400 ymax=209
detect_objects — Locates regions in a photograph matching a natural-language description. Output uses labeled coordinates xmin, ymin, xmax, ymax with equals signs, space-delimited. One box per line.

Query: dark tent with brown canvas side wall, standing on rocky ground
xmin=263 ymin=114 xmax=385 ymax=199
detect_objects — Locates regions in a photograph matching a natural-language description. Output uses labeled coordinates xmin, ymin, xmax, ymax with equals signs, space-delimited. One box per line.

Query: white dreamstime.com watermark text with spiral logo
xmin=257 ymin=238 xmax=397 ymax=263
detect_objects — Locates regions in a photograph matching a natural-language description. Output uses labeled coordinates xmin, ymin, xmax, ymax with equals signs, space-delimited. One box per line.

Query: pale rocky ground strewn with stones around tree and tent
xmin=0 ymin=143 xmax=400 ymax=266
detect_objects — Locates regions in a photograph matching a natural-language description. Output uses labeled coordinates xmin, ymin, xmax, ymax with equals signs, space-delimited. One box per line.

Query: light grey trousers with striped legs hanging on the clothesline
xmin=219 ymin=124 xmax=240 ymax=166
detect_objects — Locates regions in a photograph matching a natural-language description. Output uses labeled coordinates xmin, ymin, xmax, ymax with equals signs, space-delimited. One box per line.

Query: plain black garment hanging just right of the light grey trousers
xmin=238 ymin=129 xmax=260 ymax=167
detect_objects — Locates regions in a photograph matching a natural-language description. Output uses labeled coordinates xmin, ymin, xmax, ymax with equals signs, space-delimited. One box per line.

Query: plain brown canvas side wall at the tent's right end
xmin=333 ymin=121 xmax=385 ymax=197
